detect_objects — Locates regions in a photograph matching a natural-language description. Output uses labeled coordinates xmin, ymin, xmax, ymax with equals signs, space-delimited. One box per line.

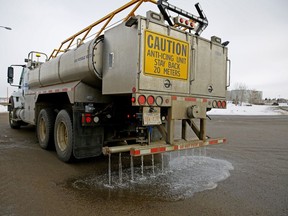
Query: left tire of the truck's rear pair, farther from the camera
xmin=36 ymin=108 xmax=55 ymax=149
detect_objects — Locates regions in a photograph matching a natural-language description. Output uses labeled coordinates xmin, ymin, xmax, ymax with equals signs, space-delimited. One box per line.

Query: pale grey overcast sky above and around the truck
xmin=0 ymin=0 xmax=288 ymax=99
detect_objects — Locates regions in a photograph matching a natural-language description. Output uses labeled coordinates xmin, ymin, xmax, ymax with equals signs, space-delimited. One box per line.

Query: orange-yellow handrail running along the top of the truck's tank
xmin=48 ymin=0 xmax=157 ymax=60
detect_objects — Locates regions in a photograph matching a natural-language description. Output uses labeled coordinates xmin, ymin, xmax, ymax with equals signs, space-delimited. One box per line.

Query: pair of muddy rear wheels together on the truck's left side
xmin=37 ymin=108 xmax=73 ymax=162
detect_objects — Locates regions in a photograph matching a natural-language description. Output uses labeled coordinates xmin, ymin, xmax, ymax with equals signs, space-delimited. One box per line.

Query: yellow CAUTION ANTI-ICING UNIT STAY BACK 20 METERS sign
xmin=144 ymin=30 xmax=189 ymax=80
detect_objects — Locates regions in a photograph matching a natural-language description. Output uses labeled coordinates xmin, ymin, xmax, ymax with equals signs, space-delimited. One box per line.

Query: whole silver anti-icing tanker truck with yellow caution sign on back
xmin=7 ymin=0 xmax=230 ymax=162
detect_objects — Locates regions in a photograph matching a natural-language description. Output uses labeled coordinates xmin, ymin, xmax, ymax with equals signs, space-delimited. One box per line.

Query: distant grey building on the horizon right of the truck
xmin=227 ymin=89 xmax=263 ymax=104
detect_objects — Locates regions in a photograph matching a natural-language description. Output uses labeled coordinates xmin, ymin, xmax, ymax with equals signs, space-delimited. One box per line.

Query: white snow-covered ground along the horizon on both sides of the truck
xmin=0 ymin=103 xmax=288 ymax=115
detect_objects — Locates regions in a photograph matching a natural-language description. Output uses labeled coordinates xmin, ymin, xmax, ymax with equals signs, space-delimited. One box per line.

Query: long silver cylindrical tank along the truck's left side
xmin=28 ymin=36 xmax=104 ymax=88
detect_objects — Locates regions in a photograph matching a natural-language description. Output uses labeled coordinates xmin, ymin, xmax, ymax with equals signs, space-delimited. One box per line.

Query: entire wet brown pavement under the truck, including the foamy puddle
xmin=0 ymin=114 xmax=288 ymax=216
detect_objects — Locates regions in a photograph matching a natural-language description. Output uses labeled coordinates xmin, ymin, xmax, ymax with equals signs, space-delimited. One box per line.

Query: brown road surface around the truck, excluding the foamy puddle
xmin=0 ymin=113 xmax=288 ymax=216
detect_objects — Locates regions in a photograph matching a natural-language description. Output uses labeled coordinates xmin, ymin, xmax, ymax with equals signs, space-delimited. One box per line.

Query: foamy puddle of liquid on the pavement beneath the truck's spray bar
xmin=72 ymin=154 xmax=234 ymax=201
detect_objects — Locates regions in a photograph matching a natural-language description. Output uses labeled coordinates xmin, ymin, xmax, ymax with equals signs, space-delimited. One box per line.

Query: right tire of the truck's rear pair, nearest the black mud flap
xmin=54 ymin=110 xmax=74 ymax=162
